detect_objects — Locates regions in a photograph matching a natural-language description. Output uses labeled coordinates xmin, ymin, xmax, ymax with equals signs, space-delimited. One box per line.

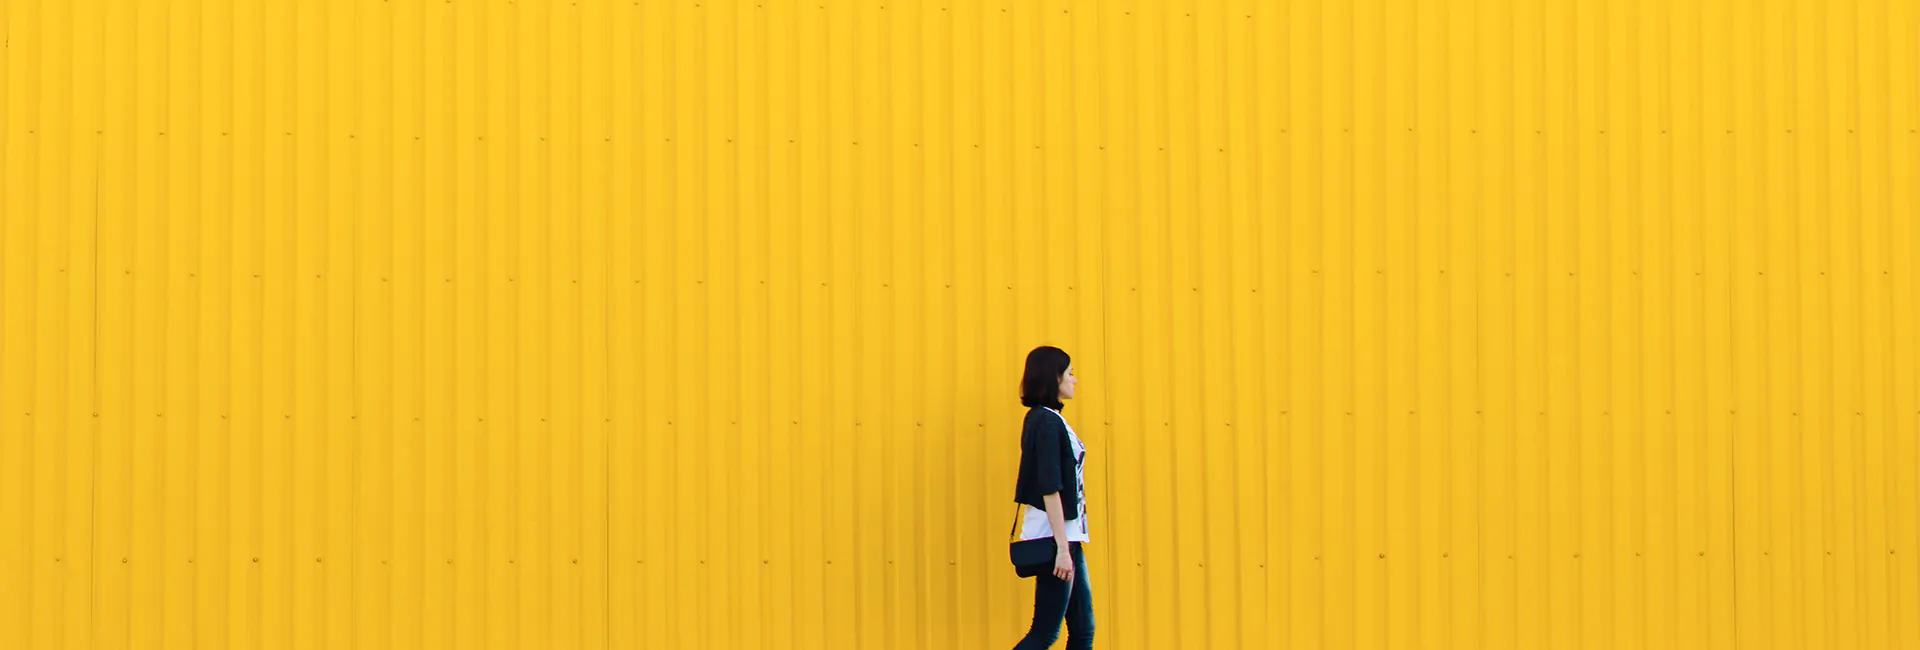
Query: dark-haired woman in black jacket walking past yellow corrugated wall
xmin=1012 ymin=347 xmax=1092 ymax=650
